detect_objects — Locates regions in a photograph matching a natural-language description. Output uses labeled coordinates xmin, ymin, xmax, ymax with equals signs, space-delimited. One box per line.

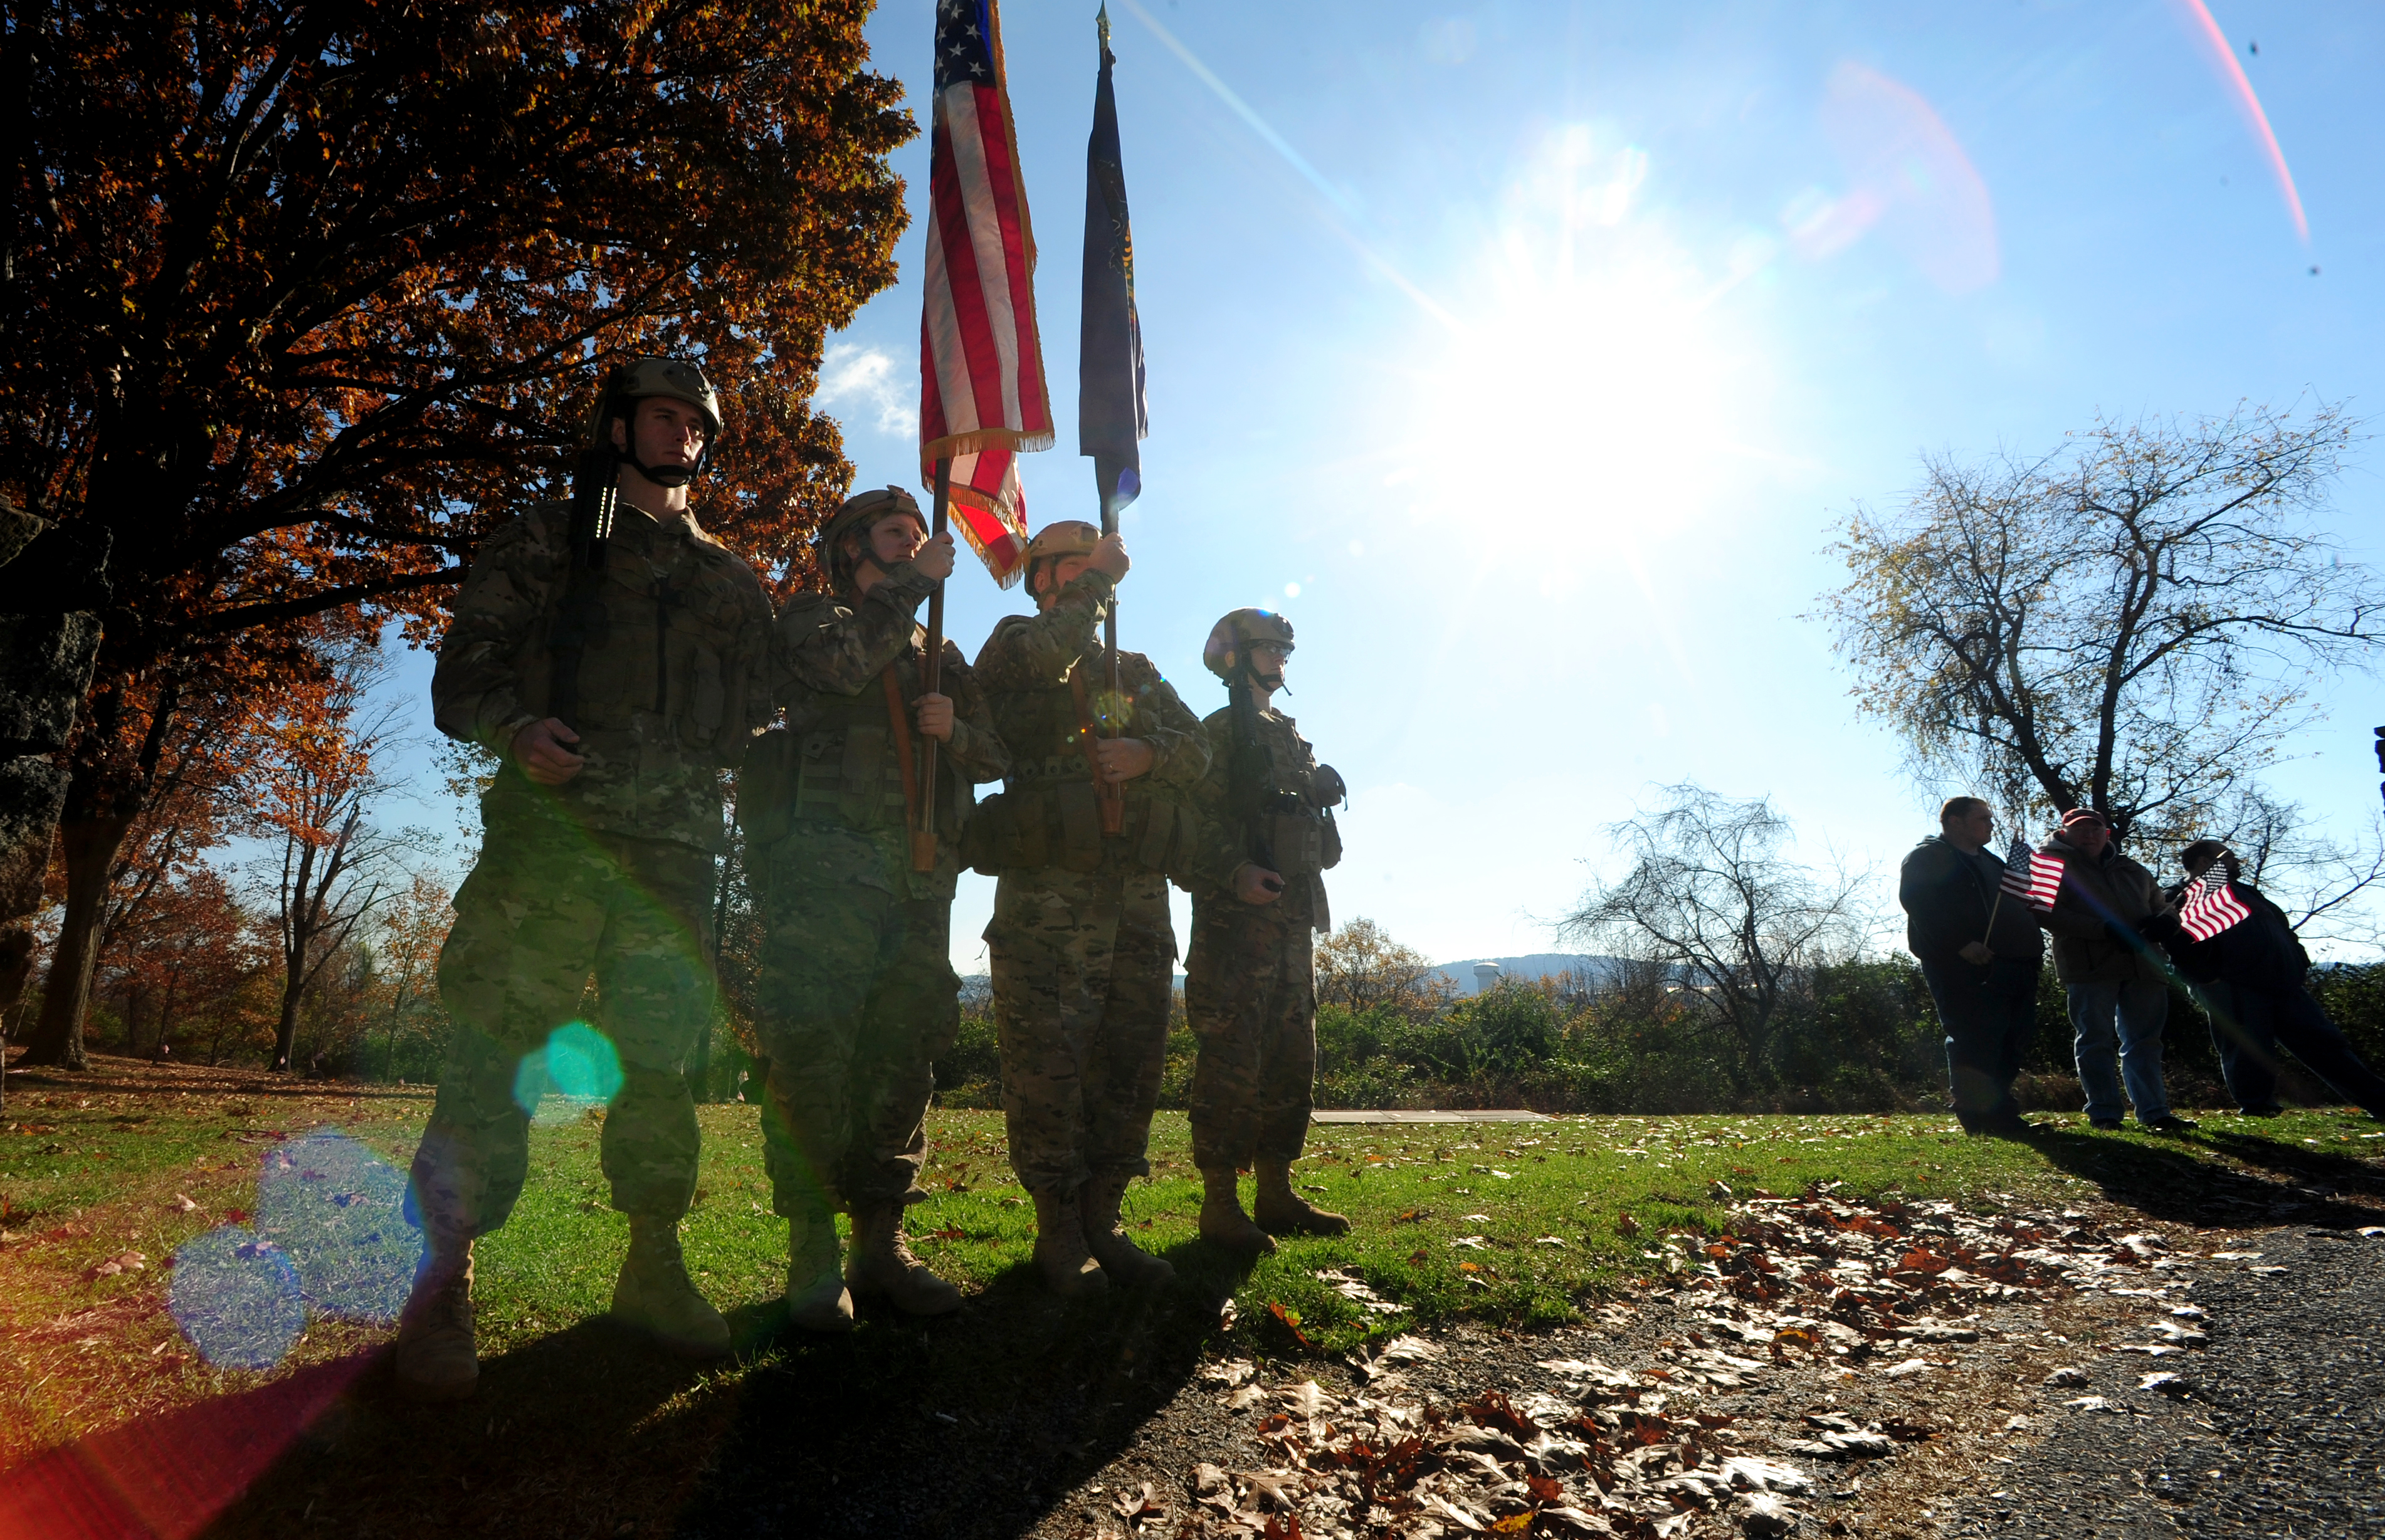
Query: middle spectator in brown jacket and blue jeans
xmin=2039 ymin=808 xmax=2194 ymax=1133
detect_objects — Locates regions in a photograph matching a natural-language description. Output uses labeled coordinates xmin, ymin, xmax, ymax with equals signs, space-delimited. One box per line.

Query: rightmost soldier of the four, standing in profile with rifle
xmin=1186 ymin=610 xmax=1350 ymax=1252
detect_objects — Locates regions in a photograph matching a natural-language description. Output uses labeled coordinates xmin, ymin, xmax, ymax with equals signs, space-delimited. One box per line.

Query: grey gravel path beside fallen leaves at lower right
xmin=1941 ymin=1228 xmax=2385 ymax=1540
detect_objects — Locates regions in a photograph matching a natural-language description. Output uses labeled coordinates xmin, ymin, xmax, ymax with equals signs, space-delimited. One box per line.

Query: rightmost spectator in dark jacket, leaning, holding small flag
xmin=2171 ymin=839 xmax=2385 ymax=1118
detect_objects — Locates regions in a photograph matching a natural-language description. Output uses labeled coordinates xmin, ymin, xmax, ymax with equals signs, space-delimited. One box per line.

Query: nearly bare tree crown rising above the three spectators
xmin=1824 ymin=406 xmax=2385 ymax=858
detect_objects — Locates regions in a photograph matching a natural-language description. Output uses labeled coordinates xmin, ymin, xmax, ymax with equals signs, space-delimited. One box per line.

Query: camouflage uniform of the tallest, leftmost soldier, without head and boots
xmin=413 ymin=505 xmax=771 ymax=1237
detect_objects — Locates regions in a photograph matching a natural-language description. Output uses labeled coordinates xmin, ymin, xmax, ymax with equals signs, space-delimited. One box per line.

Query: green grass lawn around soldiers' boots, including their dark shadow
xmin=0 ymin=1071 xmax=2385 ymax=1540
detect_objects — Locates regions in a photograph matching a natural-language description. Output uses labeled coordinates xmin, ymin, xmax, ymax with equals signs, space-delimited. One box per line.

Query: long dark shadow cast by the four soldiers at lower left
xmin=135 ymin=1242 xmax=1247 ymax=1540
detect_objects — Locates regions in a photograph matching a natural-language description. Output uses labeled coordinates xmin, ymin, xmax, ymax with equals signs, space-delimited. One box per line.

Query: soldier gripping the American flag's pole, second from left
xmin=737 ymin=486 xmax=1009 ymax=1330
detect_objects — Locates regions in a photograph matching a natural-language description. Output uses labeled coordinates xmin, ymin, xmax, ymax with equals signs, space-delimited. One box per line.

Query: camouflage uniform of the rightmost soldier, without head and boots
xmin=1186 ymin=706 xmax=1340 ymax=1170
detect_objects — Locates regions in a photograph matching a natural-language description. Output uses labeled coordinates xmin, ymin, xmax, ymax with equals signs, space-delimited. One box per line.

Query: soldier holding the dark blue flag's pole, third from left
xmin=971 ymin=522 xmax=1209 ymax=1297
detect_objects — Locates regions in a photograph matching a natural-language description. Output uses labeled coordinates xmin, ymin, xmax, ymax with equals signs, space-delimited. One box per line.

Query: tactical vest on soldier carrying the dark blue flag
xmin=961 ymin=661 xmax=1199 ymax=877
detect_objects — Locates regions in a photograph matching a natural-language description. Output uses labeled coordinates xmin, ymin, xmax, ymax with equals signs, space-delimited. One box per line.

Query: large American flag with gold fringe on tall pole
xmin=919 ymin=0 xmax=1052 ymax=587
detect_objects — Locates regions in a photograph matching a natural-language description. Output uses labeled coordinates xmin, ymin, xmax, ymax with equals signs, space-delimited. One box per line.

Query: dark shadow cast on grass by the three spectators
xmin=2030 ymin=1128 xmax=2380 ymax=1228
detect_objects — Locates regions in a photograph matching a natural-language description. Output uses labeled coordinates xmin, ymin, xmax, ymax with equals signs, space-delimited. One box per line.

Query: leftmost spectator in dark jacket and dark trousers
xmin=1896 ymin=796 xmax=2046 ymax=1134
